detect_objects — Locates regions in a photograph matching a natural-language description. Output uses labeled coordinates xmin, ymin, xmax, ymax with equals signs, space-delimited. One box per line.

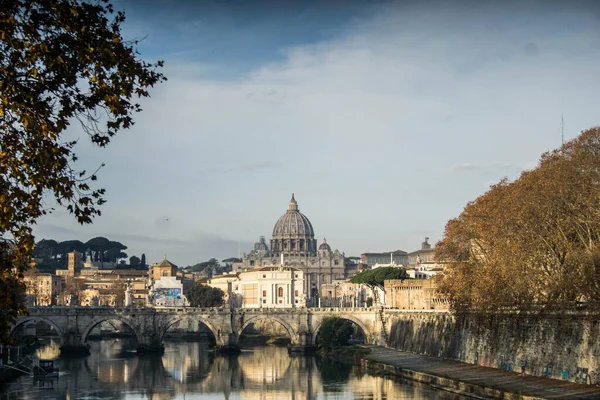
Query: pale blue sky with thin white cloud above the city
xmin=34 ymin=0 xmax=600 ymax=265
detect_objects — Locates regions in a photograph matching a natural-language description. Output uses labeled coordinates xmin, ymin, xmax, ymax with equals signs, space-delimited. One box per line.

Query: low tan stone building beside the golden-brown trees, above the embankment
xmin=384 ymin=279 xmax=449 ymax=310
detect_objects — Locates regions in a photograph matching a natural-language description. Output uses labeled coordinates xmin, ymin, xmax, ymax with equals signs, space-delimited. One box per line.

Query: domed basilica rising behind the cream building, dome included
xmin=242 ymin=194 xmax=346 ymax=299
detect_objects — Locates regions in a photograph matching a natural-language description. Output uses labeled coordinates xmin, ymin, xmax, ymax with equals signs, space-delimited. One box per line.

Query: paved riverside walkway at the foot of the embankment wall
xmin=362 ymin=346 xmax=600 ymax=400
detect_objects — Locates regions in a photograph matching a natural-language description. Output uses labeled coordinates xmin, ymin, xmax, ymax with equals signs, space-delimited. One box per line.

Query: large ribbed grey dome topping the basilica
xmin=271 ymin=194 xmax=317 ymax=256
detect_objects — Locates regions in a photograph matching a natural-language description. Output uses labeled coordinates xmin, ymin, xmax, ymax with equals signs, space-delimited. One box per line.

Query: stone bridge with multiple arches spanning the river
xmin=14 ymin=307 xmax=382 ymax=351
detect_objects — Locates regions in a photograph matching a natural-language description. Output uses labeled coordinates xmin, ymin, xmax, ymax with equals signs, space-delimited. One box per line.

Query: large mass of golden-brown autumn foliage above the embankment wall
xmin=436 ymin=128 xmax=600 ymax=311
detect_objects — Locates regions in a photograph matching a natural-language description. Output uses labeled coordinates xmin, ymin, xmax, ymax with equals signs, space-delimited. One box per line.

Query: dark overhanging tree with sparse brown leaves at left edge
xmin=0 ymin=0 xmax=164 ymax=344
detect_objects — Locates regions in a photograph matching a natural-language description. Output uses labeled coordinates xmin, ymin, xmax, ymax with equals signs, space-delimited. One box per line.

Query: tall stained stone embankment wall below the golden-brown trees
xmin=386 ymin=310 xmax=600 ymax=384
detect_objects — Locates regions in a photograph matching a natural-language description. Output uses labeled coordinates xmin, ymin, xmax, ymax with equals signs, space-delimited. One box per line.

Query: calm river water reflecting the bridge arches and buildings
xmin=0 ymin=339 xmax=465 ymax=400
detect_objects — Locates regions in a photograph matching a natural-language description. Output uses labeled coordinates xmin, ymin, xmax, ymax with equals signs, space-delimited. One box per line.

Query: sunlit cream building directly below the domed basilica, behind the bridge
xmin=207 ymin=265 xmax=306 ymax=308
